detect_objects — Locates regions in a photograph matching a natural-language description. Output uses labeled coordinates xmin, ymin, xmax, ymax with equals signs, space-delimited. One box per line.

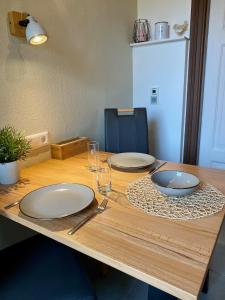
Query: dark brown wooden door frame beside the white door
xmin=183 ymin=0 xmax=210 ymax=165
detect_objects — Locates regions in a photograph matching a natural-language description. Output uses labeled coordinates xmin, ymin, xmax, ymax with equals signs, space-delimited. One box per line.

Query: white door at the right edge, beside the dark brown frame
xmin=199 ymin=0 xmax=225 ymax=169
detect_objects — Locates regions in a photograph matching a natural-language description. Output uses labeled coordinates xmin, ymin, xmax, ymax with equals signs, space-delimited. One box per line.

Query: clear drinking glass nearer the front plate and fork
xmin=97 ymin=162 xmax=112 ymax=195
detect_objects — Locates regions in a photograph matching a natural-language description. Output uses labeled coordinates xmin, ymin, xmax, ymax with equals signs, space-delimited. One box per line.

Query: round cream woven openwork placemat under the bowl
xmin=127 ymin=176 xmax=225 ymax=220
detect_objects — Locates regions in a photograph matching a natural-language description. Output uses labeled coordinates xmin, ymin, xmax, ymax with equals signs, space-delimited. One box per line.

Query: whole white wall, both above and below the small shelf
xmin=133 ymin=0 xmax=191 ymax=161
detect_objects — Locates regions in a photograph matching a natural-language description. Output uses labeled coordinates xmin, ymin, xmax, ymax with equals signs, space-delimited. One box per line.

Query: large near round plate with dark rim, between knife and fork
xmin=20 ymin=183 xmax=95 ymax=220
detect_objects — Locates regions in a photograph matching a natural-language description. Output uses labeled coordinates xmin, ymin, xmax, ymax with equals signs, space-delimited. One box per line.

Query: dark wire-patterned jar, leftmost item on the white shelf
xmin=133 ymin=19 xmax=151 ymax=43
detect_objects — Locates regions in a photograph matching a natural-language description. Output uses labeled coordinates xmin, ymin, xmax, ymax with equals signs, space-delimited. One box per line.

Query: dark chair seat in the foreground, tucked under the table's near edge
xmin=0 ymin=235 xmax=96 ymax=300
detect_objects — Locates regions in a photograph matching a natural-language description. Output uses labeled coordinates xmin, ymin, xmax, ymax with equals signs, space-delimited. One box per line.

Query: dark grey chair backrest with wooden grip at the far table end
xmin=105 ymin=108 xmax=149 ymax=153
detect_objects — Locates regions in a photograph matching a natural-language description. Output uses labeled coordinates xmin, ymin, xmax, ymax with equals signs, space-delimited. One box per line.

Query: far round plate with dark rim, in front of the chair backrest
xmin=109 ymin=152 xmax=155 ymax=169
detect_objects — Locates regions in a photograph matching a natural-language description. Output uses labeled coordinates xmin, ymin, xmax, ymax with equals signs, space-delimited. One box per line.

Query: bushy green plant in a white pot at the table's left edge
xmin=0 ymin=126 xmax=31 ymax=184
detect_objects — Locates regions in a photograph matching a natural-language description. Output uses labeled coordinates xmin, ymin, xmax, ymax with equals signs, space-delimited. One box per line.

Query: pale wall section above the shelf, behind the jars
xmin=138 ymin=0 xmax=191 ymax=37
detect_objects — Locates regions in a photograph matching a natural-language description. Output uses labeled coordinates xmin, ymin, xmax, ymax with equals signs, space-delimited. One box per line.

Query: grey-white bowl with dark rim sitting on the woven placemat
xmin=151 ymin=170 xmax=200 ymax=197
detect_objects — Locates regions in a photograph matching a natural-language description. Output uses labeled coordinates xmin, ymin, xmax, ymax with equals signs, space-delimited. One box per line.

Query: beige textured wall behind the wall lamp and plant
xmin=0 ymin=0 xmax=136 ymax=148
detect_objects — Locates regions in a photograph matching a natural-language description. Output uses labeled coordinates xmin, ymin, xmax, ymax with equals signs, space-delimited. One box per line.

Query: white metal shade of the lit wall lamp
xmin=26 ymin=16 xmax=48 ymax=45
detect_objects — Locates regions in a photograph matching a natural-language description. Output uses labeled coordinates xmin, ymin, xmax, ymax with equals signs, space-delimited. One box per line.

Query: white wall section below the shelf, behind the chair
xmin=133 ymin=40 xmax=187 ymax=162
